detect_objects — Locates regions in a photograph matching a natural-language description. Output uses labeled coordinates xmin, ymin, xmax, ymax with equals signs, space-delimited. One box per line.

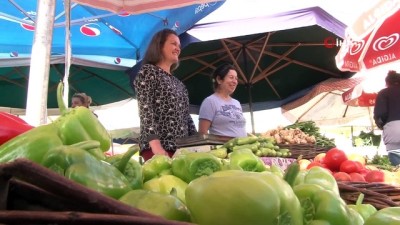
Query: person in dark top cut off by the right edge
xmin=374 ymin=71 xmax=400 ymax=166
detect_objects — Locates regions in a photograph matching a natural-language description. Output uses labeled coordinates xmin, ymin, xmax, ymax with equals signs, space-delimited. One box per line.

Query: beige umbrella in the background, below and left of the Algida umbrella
xmin=281 ymin=77 xmax=374 ymax=126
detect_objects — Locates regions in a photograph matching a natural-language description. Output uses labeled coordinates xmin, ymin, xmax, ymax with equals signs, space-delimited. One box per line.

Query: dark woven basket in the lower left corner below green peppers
xmin=0 ymin=159 xmax=191 ymax=225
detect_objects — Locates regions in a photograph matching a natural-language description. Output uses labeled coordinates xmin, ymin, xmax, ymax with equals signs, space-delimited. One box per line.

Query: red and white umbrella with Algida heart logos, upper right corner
xmin=336 ymin=0 xmax=400 ymax=72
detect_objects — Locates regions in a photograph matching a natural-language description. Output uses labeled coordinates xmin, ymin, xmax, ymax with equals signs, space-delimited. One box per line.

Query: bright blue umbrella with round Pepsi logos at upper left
xmin=0 ymin=0 xmax=223 ymax=66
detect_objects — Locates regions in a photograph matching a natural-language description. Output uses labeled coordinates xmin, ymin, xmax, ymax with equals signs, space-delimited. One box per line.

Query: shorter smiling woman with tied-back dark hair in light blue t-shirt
xmin=199 ymin=64 xmax=247 ymax=137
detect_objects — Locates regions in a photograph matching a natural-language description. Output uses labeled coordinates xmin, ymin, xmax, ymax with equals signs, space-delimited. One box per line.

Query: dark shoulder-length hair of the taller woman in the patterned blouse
xmin=142 ymin=29 xmax=179 ymax=72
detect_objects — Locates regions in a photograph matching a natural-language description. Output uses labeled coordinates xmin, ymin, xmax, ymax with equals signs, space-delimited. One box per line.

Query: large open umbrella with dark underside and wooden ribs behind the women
xmin=175 ymin=7 xmax=353 ymax=113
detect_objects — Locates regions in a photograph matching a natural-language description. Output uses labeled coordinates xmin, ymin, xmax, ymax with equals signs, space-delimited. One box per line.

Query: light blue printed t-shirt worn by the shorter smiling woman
xmin=199 ymin=94 xmax=247 ymax=137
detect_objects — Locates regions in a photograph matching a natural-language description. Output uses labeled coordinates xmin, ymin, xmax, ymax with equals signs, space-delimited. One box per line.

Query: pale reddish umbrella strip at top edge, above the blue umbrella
xmin=72 ymin=0 xmax=221 ymax=14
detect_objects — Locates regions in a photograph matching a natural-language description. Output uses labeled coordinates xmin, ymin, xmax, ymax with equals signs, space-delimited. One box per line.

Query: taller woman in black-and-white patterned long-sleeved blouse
xmin=134 ymin=29 xmax=197 ymax=160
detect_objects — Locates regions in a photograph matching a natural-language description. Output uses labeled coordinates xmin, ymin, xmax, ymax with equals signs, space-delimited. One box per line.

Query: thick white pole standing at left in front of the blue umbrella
xmin=26 ymin=0 xmax=56 ymax=126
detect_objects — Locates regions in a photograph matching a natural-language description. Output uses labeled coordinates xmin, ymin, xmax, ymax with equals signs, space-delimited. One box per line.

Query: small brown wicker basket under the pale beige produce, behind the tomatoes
xmin=278 ymin=144 xmax=330 ymax=159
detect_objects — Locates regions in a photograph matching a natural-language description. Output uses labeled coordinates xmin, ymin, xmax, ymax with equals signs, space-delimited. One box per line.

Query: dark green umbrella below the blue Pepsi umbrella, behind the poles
xmin=0 ymin=59 xmax=133 ymax=109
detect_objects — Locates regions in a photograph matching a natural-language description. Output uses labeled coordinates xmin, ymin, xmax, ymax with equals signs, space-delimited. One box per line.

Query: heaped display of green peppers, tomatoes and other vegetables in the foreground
xmin=0 ymin=83 xmax=400 ymax=225
